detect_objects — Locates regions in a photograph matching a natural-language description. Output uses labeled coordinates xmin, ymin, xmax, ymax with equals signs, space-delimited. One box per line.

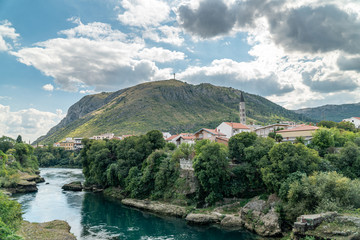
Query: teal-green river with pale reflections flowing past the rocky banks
xmin=14 ymin=168 xmax=256 ymax=240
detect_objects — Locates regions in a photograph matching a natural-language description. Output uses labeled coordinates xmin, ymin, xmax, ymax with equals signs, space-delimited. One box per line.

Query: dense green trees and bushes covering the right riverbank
xmin=80 ymin=128 xmax=360 ymax=224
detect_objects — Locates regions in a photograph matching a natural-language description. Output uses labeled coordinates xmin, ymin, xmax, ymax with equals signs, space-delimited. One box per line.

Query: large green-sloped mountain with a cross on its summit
xmin=35 ymin=80 xmax=311 ymax=143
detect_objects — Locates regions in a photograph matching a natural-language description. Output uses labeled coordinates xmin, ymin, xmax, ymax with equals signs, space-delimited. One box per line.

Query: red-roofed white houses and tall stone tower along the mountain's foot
xmin=41 ymin=94 xmax=360 ymax=151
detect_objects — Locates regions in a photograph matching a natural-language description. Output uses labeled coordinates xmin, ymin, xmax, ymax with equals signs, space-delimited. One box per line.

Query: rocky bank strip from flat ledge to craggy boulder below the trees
xmin=121 ymin=195 xmax=281 ymax=237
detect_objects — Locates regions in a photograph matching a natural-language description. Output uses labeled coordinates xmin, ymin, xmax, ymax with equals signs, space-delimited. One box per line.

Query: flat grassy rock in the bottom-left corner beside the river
xmin=16 ymin=220 xmax=76 ymax=240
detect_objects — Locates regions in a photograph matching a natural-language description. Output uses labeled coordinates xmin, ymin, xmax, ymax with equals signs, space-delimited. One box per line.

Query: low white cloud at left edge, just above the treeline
xmin=0 ymin=104 xmax=65 ymax=142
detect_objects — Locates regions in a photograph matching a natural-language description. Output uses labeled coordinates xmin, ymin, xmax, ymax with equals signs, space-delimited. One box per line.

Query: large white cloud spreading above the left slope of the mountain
xmin=10 ymin=20 xmax=185 ymax=92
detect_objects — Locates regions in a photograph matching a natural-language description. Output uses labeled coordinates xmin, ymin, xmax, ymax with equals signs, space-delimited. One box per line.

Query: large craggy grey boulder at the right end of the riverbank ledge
xmin=240 ymin=195 xmax=281 ymax=237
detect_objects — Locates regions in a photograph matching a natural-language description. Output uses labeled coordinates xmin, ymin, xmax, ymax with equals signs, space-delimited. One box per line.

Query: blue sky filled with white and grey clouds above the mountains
xmin=0 ymin=0 xmax=360 ymax=142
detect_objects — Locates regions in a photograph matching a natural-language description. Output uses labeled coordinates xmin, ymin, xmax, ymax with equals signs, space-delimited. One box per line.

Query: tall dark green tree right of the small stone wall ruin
xmin=193 ymin=142 xmax=229 ymax=205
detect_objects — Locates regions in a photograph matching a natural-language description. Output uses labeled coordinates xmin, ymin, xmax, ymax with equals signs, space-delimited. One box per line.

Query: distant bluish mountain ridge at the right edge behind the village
xmin=295 ymin=103 xmax=360 ymax=122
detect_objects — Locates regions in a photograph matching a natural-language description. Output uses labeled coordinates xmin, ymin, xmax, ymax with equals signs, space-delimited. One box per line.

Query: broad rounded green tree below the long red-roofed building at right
xmin=259 ymin=142 xmax=321 ymax=193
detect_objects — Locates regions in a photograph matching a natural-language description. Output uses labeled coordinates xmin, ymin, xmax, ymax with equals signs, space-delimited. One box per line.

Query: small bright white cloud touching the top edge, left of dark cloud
xmin=118 ymin=0 xmax=170 ymax=28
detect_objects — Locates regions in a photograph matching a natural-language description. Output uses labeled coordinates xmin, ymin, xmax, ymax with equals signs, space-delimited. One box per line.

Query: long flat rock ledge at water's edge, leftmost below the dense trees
xmin=121 ymin=198 xmax=186 ymax=218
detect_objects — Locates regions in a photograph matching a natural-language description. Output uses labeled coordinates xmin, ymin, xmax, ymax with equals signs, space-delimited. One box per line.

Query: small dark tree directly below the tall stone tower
xmin=229 ymin=132 xmax=257 ymax=162
